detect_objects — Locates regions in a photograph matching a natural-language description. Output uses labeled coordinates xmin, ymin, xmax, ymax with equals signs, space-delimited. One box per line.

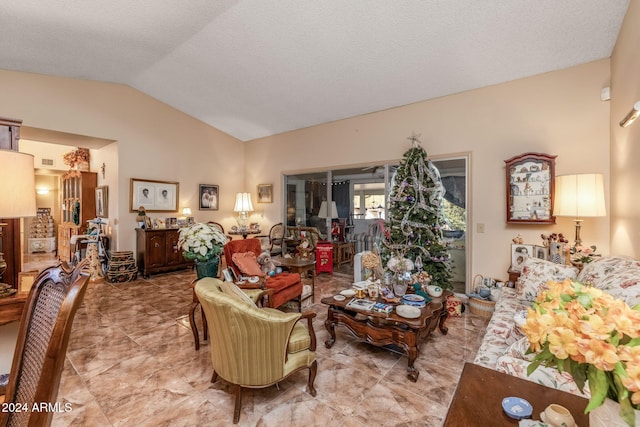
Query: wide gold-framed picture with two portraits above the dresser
xmin=129 ymin=178 xmax=180 ymax=212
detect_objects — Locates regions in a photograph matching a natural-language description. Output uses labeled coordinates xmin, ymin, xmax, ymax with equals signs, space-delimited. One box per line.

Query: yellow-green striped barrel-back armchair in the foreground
xmin=195 ymin=277 xmax=318 ymax=424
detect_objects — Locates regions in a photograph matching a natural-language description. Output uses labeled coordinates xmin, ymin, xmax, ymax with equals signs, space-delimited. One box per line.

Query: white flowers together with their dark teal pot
xmin=178 ymin=223 xmax=228 ymax=278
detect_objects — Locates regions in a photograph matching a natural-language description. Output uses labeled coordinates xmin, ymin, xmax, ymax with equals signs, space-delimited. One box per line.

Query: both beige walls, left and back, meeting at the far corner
xmin=0 ymin=60 xmax=610 ymax=284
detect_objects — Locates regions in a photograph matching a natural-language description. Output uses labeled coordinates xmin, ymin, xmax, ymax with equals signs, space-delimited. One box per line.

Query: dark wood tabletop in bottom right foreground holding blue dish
xmin=443 ymin=363 xmax=589 ymax=427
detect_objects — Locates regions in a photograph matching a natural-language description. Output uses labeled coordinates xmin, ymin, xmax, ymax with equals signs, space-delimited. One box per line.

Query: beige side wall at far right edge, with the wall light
xmin=611 ymin=1 xmax=640 ymax=258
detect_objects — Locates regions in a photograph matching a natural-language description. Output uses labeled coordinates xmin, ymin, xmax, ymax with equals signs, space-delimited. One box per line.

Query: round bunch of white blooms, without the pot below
xmin=178 ymin=223 xmax=228 ymax=262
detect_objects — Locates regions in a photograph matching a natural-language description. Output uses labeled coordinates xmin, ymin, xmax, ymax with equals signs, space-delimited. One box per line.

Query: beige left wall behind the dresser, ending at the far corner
xmin=0 ymin=70 xmax=245 ymax=250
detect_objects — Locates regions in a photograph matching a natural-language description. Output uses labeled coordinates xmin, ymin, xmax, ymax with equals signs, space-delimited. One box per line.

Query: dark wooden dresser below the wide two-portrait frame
xmin=136 ymin=228 xmax=191 ymax=278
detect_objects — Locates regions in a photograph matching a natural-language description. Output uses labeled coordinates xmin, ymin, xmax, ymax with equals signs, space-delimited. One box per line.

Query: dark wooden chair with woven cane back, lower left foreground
xmin=0 ymin=260 xmax=89 ymax=427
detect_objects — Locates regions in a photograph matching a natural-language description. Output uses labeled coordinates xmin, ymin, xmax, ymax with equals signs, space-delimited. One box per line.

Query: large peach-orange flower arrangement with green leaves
xmin=522 ymin=280 xmax=640 ymax=426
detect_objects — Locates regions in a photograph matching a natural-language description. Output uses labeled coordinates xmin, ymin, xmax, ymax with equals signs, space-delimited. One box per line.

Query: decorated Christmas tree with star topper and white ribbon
xmin=382 ymin=134 xmax=452 ymax=289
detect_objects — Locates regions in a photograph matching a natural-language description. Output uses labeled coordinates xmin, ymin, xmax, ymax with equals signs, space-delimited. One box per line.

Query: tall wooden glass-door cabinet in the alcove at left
xmin=58 ymin=171 xmax=98 ymax=262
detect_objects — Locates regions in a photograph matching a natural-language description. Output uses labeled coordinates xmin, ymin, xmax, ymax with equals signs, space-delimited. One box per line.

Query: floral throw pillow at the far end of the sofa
xmin=516 ymin=257 xmax=578 ymax=301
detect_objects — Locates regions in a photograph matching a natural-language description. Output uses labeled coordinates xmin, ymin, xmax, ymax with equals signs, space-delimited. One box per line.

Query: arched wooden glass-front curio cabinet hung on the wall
xmin=504 ymin=153 xmax=557 ymax=224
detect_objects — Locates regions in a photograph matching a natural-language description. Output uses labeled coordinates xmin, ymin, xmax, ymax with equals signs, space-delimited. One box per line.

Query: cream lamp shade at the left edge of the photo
xmin=0 ymin=150 xmax=36 ymax=218
